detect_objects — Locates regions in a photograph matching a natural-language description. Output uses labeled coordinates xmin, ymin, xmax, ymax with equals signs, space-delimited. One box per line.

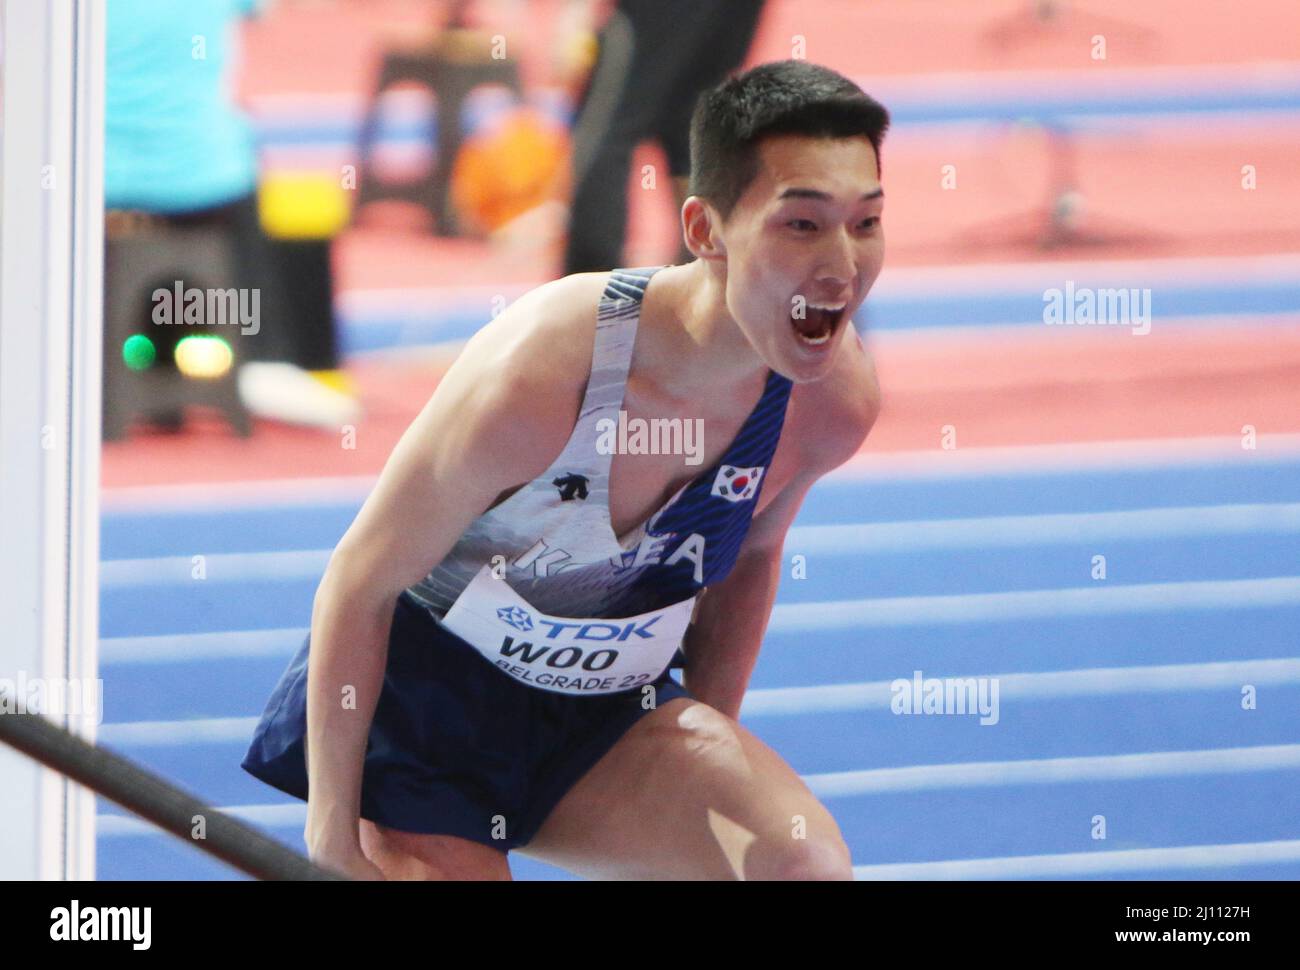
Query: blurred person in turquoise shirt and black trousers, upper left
xmin=104 ymin=0 xmax=315 ymax=390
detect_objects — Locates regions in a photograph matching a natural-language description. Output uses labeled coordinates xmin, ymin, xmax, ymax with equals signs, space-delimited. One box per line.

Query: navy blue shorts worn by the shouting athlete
xmin=242 ymin=582 xmax=690 ymax=850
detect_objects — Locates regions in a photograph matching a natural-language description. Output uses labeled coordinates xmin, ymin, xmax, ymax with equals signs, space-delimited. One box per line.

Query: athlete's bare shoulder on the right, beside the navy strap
xmin=789 ymin=330 xmax=881 ymax=472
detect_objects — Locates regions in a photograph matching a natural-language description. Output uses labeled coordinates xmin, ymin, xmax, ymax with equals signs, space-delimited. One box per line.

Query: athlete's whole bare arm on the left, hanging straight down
xmin=304 ymin=283 xmax=594 ymax=863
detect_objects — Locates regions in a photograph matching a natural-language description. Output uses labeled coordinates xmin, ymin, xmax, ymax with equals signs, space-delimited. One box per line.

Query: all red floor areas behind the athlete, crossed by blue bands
xmin=103 ymin=0 xmax=1300 ymax=488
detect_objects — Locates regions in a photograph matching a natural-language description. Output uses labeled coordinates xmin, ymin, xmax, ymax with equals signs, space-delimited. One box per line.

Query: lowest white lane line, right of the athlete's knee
xmin=853 ymin=839 xmax=1300 ymax=880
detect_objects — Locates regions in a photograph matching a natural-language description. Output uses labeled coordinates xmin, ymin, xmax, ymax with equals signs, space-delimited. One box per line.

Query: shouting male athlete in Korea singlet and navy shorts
xmin=243 ymin=61 xmax=889 ymax=879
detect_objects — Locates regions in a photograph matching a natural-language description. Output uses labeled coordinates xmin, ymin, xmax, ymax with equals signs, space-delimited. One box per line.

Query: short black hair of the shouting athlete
xmin=690 ymin=60 xmax=889 ymax=221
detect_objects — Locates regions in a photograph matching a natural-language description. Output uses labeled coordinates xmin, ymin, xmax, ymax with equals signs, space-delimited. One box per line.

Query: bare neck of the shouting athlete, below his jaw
xmin=647 ymin=259 xmax=767 ymax=399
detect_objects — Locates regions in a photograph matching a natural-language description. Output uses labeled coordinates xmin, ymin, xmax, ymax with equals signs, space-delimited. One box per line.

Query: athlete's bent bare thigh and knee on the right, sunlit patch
xmin=519 ymin=698 xmax=852 ymax=879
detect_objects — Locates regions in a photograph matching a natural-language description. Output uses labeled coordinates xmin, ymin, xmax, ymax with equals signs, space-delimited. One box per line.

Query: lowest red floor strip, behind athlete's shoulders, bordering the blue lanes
xmin=104 ymin=320 xmax=1300 ymax=486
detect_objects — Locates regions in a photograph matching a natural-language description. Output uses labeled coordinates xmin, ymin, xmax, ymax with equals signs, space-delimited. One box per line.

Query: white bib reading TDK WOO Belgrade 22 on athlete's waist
xmin=442 ymin=566 xmax=696 ymax=694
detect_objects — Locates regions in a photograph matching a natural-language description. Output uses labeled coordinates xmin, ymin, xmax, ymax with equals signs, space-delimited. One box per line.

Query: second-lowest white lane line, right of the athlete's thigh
xmin=803 ymin=744 xmax=1300 ymax=798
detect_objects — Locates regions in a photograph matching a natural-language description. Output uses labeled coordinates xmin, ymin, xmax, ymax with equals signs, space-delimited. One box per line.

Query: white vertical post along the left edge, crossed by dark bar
xmin=0 ymin=0 xmax=104 ymax=879
